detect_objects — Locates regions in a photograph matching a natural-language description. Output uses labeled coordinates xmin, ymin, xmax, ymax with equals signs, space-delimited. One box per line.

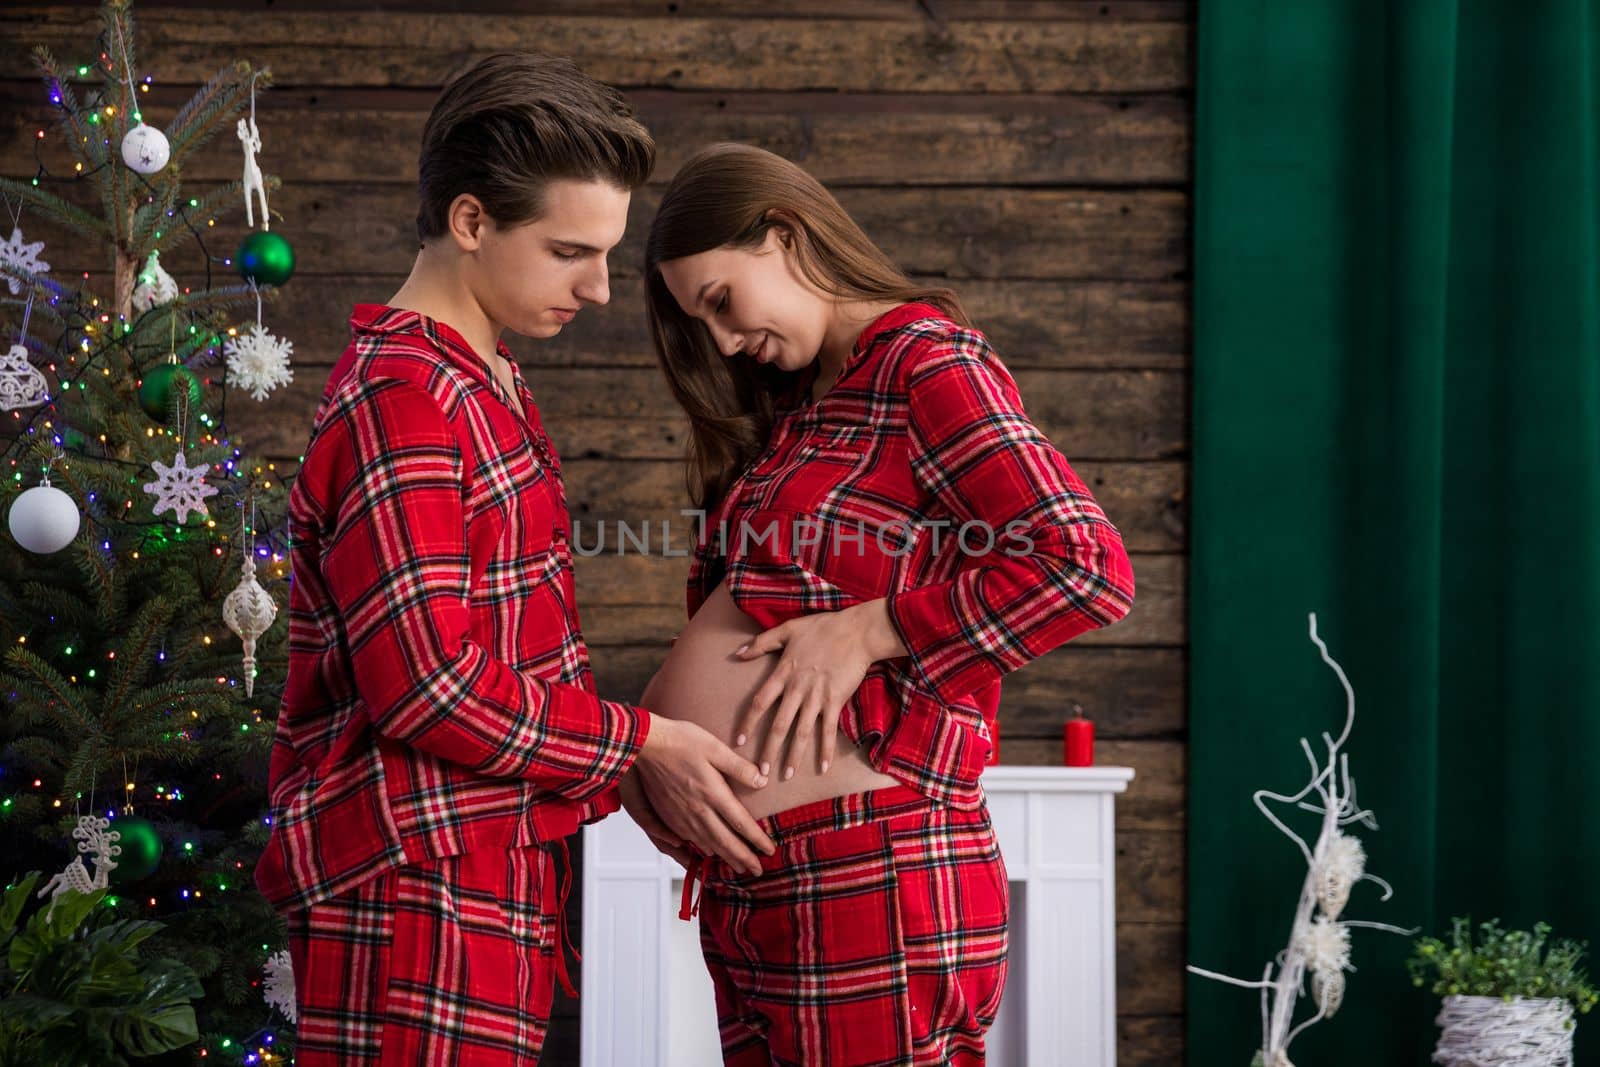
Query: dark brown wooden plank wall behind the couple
xmin=0 ymin=0 xmax=1194 ymax=1065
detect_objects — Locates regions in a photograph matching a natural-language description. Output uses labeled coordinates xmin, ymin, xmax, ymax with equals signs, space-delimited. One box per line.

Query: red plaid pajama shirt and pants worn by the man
xmin=256 ymin=306 xmax=650 ymax=1064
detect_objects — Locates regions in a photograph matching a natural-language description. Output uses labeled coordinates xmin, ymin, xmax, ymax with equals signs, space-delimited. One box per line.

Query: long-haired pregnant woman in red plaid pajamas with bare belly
xmin=624 ymin=144 xmax=1133 ymax=1065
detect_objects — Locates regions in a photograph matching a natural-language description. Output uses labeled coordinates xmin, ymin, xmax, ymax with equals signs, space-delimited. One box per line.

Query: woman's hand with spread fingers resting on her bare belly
xmin=734 ymin=600 xmax=907 ymax=781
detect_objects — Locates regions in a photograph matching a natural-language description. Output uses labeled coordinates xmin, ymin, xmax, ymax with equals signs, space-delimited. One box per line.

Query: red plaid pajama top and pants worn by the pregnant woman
xmin=685 ymin=304 xmax=1133 ymax=1067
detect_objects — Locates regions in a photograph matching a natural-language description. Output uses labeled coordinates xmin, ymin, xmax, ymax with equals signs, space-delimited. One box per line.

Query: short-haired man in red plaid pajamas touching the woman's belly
xmin=256 ymin=53 xmax=771 ymax=1067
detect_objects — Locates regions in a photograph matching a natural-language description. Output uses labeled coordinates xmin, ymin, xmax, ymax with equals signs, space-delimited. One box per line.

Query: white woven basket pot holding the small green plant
xmin=1434 ymin=997 xmax=1574 ymax=1067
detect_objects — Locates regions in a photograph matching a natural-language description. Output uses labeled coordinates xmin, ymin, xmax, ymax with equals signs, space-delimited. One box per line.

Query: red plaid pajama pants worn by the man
xmin=288 ymin=841 xmax=570 ymax=1067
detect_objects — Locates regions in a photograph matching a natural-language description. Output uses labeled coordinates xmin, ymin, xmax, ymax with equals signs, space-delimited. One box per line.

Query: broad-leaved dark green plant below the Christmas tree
xmin=0 ymin=872 xmax=202 ymax=1067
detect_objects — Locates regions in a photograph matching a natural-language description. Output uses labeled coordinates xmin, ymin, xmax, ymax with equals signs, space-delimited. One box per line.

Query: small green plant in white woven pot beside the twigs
xmin=1406 ymin=918 xmax=1600 ymax=1067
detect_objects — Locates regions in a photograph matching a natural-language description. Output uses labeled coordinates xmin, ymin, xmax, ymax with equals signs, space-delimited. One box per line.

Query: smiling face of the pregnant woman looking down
xmin=661 ymin=227 xmax=834 ymax=371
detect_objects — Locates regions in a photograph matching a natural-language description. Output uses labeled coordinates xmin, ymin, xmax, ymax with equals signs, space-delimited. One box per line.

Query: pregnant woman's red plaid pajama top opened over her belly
xmin=688 ymin=304 xmax=1133 ymax=809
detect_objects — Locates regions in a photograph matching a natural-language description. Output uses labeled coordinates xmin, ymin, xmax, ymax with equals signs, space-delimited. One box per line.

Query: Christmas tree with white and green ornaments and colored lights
xmin=0 ymin=0 xmax=293 ymax=1064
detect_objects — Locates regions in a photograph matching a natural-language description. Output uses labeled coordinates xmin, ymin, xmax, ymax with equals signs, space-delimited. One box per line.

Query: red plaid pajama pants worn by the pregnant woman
xmin=685 ymin=785 xmax=1008 ymax=1067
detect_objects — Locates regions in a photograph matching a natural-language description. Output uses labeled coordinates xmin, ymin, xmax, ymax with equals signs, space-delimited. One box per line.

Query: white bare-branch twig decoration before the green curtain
xmin=1189 ymin=613 xmax=1418 ymax=1067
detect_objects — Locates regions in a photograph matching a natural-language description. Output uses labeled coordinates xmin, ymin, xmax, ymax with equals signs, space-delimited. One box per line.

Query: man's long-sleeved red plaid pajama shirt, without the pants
xmin=256 ymin=306 xmax=650 ymax=910
